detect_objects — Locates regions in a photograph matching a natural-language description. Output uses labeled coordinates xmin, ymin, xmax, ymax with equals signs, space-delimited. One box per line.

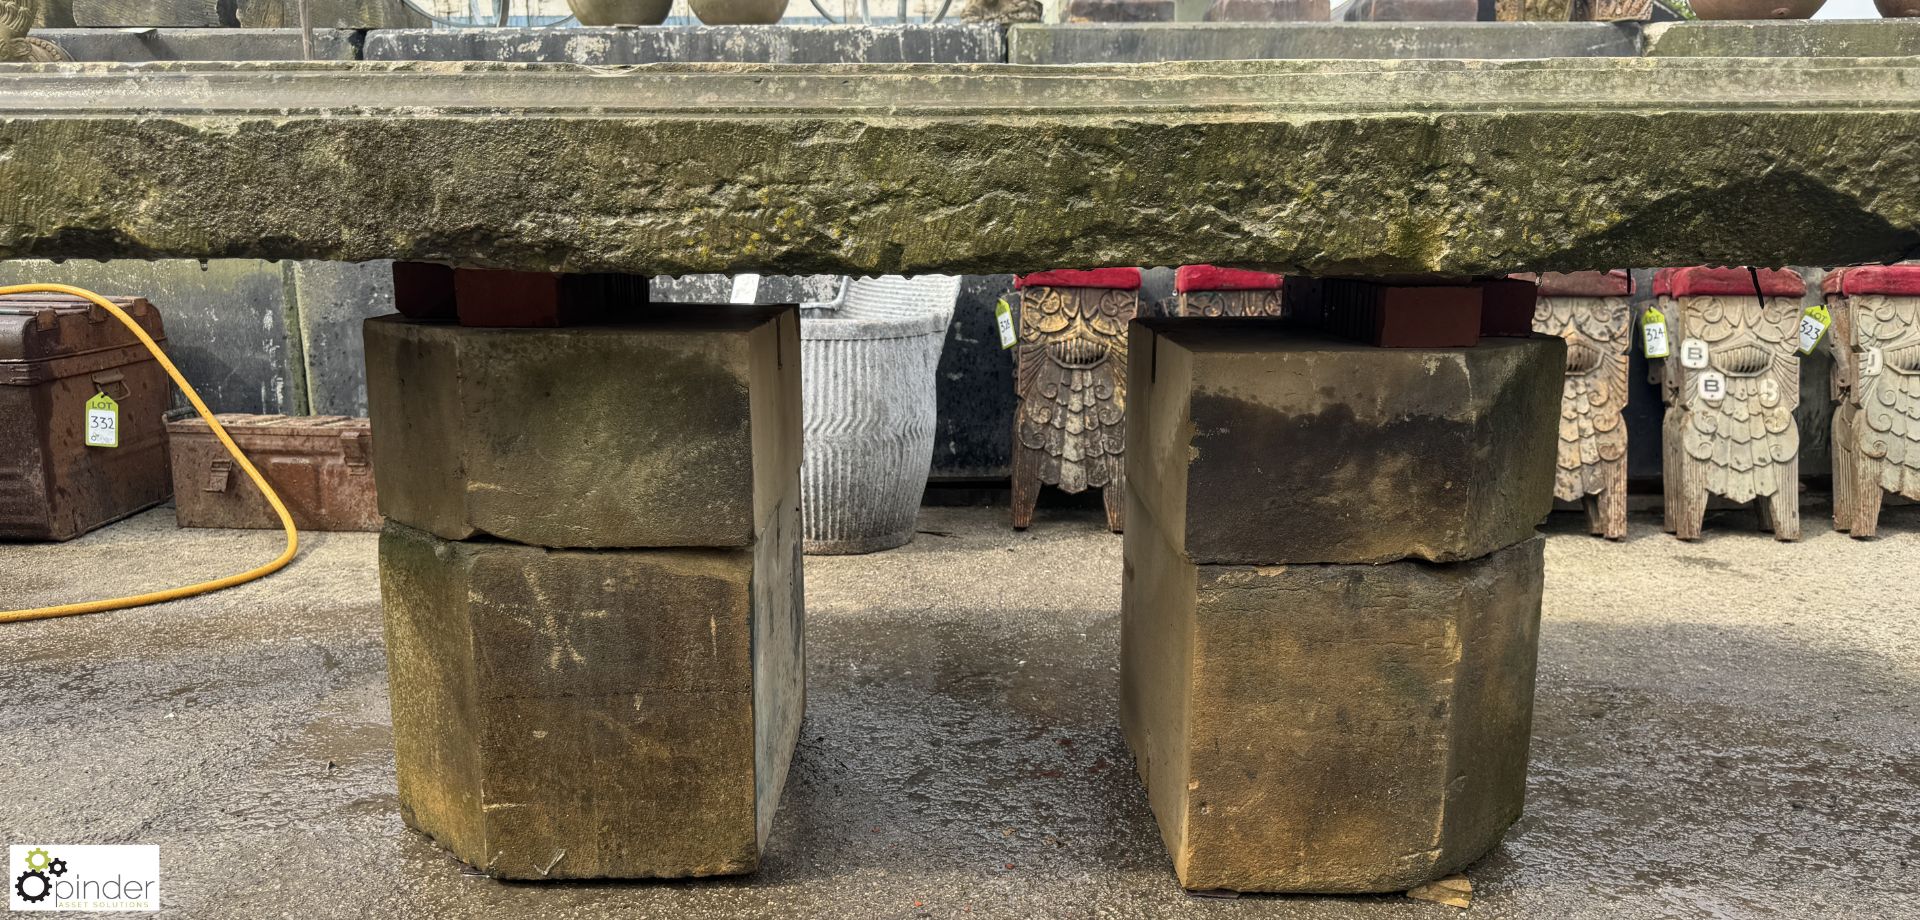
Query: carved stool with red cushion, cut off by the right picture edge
xmin=1820 ymin=265 xmax=1920 ymax=538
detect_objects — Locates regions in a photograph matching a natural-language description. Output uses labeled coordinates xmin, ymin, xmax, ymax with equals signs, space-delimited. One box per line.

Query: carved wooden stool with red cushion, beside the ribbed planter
xmin=1014 ymin=269 xmax=1140 ymax=534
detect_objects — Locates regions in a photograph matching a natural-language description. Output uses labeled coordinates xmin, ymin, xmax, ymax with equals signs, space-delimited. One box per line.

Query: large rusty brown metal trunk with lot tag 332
xmin=0 ymin=294 xmax=173 ymax=540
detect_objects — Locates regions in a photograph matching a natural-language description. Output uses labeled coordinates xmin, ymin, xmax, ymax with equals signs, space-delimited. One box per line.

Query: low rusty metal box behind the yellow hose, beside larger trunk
xmin=167 ymin=411 xmax=380 ymax=530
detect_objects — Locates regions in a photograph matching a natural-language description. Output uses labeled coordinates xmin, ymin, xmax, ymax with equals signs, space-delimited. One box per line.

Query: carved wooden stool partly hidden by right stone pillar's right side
xmin=1534 ymin=269 xmax=1634 ymax=540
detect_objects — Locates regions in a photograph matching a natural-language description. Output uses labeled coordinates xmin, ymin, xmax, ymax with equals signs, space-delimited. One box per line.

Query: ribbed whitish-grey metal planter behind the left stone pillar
xmin=801 ymin=277 xmax=960 ymax=555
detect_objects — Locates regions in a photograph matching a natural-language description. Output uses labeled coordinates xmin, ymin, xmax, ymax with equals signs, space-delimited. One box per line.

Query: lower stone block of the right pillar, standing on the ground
xmin=1121 ymin=526 xmax=1544 ymax=893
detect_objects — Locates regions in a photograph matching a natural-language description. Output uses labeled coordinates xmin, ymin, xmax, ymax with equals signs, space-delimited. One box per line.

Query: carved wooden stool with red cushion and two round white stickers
xmin=1653 ymin=267 xmax=1807 ymax=540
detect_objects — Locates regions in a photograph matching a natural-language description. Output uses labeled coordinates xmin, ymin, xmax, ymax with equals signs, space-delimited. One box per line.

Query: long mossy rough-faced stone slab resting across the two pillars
xmin=0 ymin=60 xmax=1920 ymax=277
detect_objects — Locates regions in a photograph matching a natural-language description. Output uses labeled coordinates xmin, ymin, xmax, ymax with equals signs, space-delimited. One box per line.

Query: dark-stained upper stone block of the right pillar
xmin=1127 ymin=319 xmax=1567 ymax=565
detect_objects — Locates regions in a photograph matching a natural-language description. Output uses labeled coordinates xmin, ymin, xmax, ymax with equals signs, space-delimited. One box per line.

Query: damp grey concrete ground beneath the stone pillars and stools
xmin=0 ymin=509 xmax=1920 ymax=920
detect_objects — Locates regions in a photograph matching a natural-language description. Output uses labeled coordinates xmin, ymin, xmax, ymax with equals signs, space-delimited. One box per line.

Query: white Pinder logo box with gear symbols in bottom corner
xmin=6 ymin=843 xmax=159 ymax=910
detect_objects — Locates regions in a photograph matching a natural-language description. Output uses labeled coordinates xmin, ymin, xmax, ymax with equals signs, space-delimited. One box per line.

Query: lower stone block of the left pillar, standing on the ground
xmin=380 ymin=501 xmax=804 ymax=880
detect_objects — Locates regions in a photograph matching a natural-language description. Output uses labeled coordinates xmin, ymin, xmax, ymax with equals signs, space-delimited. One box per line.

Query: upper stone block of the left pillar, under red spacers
xmin=365 ymin=303 xmax=801 ymax=547
